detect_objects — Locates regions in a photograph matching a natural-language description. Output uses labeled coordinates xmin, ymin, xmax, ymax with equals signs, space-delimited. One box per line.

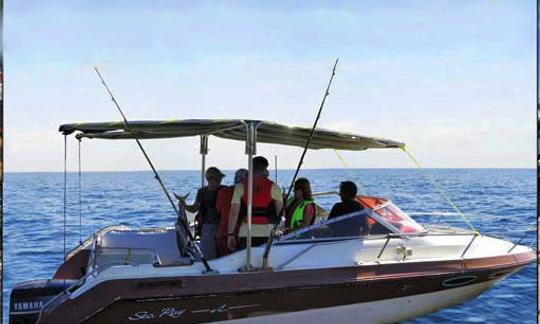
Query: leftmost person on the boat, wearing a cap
xmin=186 ymin=167 xmax=225 ymax=259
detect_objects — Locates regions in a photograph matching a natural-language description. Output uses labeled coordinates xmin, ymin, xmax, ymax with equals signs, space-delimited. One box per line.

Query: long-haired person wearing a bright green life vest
xmin=285 ymin=178 xmax=316 ymax=232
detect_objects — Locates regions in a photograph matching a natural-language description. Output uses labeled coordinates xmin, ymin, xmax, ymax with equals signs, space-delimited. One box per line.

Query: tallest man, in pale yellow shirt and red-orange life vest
xmin=227 ymin=156 xmax=283 ymax=251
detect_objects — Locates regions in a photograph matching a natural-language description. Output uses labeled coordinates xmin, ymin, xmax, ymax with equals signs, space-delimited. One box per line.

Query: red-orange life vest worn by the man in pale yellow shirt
xmin=240 ymin=176 xmax=277 ymax=224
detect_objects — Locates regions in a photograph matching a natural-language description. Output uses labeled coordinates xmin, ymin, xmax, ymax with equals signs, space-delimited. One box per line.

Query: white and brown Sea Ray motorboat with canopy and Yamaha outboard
xmin=9 ymin=119 xmax=536 ymax=324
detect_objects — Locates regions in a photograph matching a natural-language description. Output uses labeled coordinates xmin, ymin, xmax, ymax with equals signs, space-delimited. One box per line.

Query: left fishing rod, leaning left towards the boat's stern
xmin=94 ymin=67 xmax=213 ymax=272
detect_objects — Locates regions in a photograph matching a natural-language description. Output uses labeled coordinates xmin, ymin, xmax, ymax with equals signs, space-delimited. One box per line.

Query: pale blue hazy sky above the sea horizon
xmin=3 ymin=0 xmax=536 ymax=172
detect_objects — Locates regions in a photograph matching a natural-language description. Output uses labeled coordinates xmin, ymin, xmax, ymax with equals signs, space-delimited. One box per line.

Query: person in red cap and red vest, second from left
xmin=216 ymin=169 xmax=248 ymax=256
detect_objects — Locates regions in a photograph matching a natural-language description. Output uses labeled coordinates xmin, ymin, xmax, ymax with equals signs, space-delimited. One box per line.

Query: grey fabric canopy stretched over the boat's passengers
xmin=59 ymin=119 xmax=405 ymax=151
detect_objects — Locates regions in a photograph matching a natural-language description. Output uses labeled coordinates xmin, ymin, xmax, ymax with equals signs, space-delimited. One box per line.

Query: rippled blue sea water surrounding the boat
xmin=3 ymin=169 xmax=537 ymax=323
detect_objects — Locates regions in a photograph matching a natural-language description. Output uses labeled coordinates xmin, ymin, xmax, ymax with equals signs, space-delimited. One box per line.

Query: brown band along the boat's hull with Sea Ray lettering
xmin=42 ymin=252 xmax=535 ymax=323
